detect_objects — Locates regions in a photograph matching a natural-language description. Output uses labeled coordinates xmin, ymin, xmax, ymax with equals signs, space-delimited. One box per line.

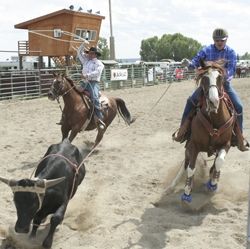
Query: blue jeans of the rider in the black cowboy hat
xmin=80 ymin=81 xmax=103 ymax=120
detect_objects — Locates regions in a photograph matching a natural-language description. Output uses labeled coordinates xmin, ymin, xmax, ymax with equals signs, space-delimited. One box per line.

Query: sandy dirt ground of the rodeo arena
xmin=0 ymin=78 xmax=250 ymax=249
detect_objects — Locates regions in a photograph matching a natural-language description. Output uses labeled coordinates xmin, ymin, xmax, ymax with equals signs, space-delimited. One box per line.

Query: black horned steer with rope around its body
xmin=0 ymin=139 xmax=85 ymax=248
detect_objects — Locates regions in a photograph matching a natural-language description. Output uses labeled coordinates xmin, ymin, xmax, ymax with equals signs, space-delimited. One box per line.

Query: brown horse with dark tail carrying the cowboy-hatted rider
xmin=48 ymin=74 xmax=134 ymax=147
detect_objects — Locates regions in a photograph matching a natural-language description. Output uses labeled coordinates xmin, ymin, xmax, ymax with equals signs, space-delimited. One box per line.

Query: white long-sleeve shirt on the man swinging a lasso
xmin=77 ymin=43 xmax=104 ymax=82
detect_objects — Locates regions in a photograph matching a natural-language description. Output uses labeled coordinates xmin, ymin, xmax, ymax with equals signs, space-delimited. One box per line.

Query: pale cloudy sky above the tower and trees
xmin=0 ymin=0 xmax=250 ymax=61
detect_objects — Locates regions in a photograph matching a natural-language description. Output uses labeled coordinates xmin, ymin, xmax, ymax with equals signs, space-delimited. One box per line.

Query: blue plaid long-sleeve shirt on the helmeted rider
xmin=189 ymin=44 xmax=237 ymax=81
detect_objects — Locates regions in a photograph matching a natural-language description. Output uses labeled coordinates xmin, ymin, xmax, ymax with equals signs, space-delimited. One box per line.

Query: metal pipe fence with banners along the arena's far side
xmin=0 ymin=65 xmax=194 ymax=101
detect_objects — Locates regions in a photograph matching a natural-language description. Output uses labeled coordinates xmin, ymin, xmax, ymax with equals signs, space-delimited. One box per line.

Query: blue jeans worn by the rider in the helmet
xmin=181 ymin=81 xmax=243 ymax=132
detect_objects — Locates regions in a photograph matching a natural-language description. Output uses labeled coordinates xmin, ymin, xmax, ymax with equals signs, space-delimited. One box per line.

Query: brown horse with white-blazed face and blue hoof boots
xmin=182 ymin=62 xmax=236 ymax=202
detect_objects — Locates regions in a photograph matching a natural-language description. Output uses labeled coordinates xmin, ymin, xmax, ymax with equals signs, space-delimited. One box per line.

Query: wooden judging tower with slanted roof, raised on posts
xmin=15 ymin=9 xmax=105 ymax=68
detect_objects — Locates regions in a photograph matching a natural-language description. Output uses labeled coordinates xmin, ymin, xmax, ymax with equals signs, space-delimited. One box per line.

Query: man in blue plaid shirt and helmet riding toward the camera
xmin=173 ymin=28 xmax=249 ymax=151
